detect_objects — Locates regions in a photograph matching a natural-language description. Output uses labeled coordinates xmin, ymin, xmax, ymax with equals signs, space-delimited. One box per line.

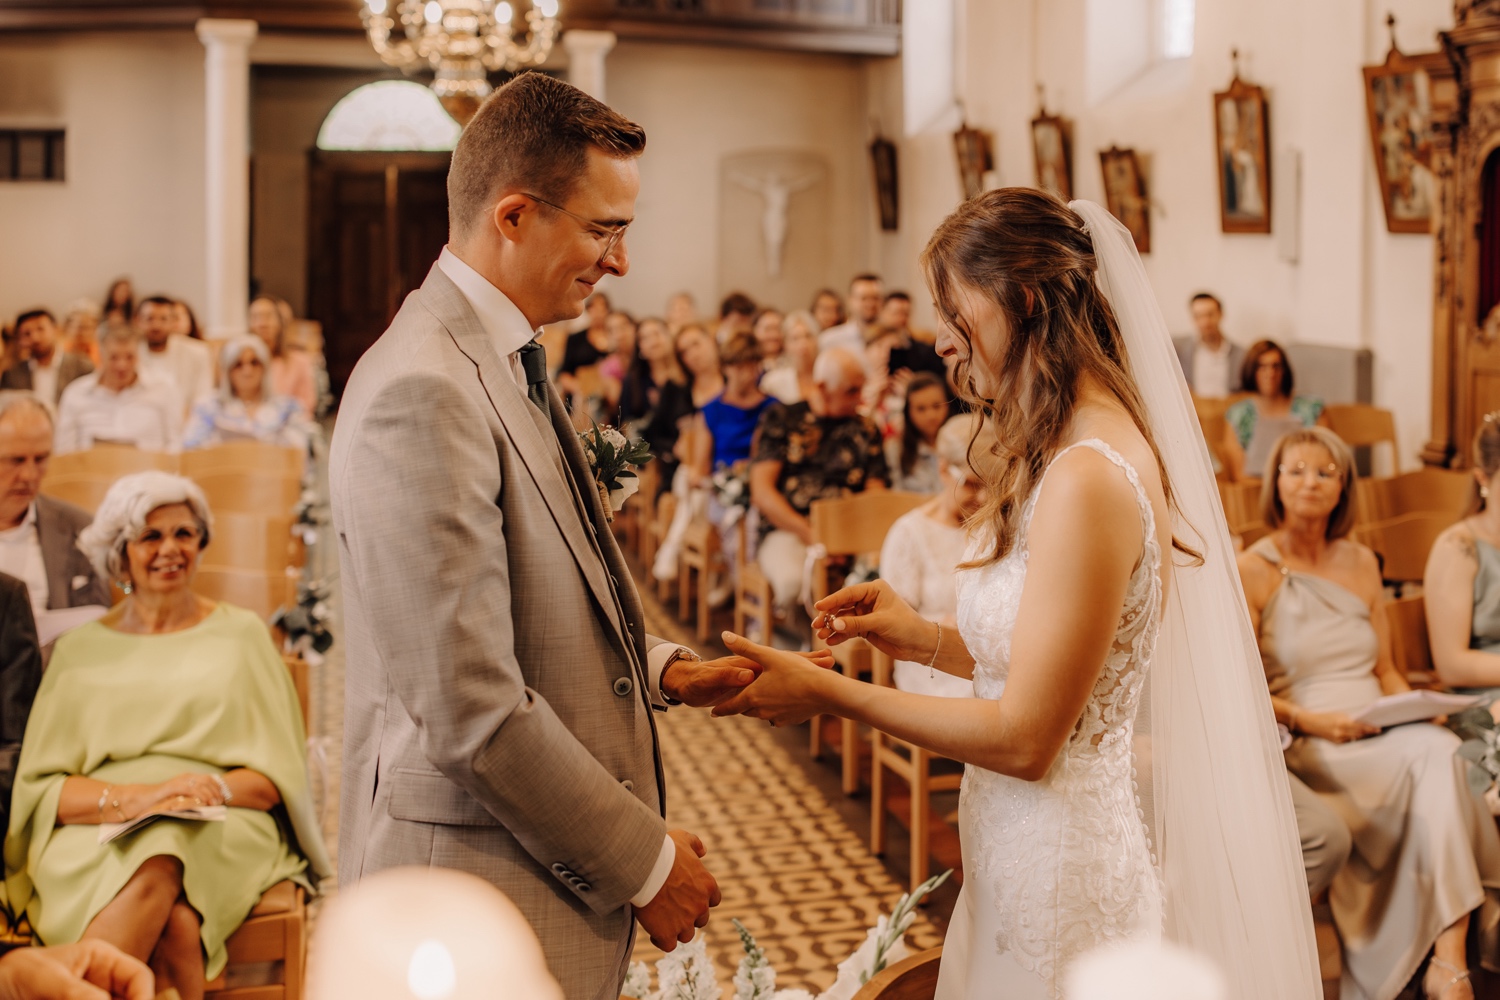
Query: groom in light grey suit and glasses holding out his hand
xmin=329 ymin=73 xmax=755 ymax=1000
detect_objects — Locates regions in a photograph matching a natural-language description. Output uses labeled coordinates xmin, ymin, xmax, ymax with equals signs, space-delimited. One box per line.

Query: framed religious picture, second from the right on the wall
xmin=1214 ymin=52 xmax=1271 ymax=232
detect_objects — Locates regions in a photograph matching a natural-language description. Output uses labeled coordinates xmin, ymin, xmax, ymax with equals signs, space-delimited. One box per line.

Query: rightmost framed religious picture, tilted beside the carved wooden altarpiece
xmin=1365 ymin=16 xmax=1446 ymax=232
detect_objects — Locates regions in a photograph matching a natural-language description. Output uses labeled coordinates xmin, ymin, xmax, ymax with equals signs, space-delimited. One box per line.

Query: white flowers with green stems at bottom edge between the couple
xmin=621 ymin=868 xmax=953 ymax=1000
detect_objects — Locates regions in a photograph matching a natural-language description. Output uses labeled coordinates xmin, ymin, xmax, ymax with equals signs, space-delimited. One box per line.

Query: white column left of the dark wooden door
xmin=197 ymin=18 xmax=258 ymax=339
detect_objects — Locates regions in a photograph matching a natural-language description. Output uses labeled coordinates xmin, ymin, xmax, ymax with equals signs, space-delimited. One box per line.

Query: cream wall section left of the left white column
xmin=0 ymin=31 xmax=207 ymax=325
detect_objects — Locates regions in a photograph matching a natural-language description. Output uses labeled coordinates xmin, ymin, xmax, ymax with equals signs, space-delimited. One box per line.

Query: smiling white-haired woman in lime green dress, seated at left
xmin=5 ymin=472 xmax=330 ymax=1000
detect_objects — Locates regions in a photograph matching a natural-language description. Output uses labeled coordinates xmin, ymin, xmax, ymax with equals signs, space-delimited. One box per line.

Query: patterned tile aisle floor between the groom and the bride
xmin=636 ymin=598 xmax=942 ymax=994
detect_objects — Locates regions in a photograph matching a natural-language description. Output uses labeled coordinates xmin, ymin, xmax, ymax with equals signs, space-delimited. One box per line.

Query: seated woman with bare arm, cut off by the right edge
xmin=1422 ymin=412 xmax=1500 ymax=712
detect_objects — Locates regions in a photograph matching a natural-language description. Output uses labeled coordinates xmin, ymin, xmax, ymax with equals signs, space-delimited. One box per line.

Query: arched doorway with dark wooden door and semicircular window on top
xmin=308 ymin=79 xmax=461 ymax=391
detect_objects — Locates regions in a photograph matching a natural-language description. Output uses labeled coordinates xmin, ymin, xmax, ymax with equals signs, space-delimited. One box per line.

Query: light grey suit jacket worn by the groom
xmin=337 ymin=267 xmax=666 ymax=1000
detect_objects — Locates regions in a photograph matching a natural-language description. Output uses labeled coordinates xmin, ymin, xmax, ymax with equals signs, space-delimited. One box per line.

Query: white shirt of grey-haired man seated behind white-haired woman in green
xmin=53 ymin=372 xmax=183 ymax=454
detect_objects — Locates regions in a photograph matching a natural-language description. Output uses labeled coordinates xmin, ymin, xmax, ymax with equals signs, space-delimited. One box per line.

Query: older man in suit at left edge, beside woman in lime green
xmin=0 ymin=391 xmax=110 ymax=618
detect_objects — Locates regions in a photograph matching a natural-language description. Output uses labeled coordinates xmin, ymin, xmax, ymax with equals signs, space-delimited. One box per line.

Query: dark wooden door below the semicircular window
xmin=308 ymin=150 xmax=449 ymax=393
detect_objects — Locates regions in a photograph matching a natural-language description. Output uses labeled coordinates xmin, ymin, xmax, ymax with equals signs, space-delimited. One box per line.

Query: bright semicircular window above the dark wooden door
xmin=318 ymin=79 xmax=464 ymax=150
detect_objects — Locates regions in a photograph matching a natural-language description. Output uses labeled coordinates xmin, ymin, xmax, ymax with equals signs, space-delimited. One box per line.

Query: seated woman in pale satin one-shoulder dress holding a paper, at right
xmin=1239 ymin=427 xmax=1500 ymax=1000
